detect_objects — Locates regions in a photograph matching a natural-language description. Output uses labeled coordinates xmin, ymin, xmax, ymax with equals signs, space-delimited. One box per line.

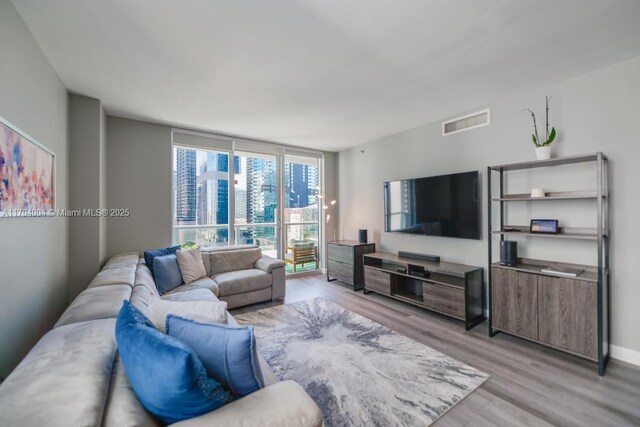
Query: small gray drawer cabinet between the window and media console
xmin=327 ymin=240 xmax=376 ymax=291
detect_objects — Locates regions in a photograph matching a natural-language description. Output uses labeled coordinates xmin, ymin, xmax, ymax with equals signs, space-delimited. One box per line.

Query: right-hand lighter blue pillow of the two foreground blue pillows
xmin=167 ymin=314 xmax=264 ymax=396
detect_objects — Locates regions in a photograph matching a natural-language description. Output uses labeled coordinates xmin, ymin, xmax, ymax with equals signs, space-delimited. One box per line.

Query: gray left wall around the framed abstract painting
xmin=0 ymin=1 xmax=68 ymax=377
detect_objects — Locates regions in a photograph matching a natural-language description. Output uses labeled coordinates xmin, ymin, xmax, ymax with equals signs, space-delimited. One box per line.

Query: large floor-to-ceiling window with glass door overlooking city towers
xmin=173 ymin=141 xmax=322 ymax=273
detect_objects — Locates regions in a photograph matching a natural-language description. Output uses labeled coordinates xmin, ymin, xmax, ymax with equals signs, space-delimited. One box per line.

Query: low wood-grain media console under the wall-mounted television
xmin=364 ymin=252 xmax=485 ymax=330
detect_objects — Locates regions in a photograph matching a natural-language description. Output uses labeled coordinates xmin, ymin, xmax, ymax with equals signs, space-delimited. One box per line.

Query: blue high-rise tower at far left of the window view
xmin=176 ymin=147 xmax=196 ymax=225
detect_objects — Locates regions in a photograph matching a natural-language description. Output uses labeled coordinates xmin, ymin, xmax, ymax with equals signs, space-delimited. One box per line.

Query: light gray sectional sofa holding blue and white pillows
xmin=0 ymin=247 xmax=322 ymax=427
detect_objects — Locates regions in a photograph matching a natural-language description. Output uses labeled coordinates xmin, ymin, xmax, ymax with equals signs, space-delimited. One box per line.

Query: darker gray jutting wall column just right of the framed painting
xmin=69 ymin=95 xmax=107 ymax=302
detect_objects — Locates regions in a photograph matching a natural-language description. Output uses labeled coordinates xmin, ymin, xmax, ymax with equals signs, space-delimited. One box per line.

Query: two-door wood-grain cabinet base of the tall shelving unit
xmin=491 ymin=266 xmax=598 ymax=361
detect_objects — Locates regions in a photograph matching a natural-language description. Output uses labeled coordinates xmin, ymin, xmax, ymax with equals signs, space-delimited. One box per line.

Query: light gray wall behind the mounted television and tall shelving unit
xmin=339 ymin=57 xmax=640 ymax=357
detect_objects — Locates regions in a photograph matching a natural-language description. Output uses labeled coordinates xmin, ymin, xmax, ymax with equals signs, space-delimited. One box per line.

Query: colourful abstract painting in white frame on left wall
xmin=0 ymin=117 xmax=56 ymax=218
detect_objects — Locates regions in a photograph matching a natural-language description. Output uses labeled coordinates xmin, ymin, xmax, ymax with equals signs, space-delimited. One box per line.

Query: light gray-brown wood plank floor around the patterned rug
xmin=232 ymin=275 xmax=640 ymax=427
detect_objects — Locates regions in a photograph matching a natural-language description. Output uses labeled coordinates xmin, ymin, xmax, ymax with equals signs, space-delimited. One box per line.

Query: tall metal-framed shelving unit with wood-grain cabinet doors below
xmin=487 ymin=153 xmax=611 ymax=375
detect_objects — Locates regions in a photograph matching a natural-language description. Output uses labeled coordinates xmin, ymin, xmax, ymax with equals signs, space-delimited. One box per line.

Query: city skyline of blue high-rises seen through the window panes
xmin=173 ymin=146 xmax=320 ymax=254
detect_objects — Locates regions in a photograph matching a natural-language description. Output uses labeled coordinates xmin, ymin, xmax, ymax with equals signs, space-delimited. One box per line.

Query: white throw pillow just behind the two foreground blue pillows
xmin=149 ymin=298 xmax=227 ymax=333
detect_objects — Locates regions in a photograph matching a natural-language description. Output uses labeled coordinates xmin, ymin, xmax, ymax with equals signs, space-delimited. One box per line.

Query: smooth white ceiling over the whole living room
xmin=13 ymin=0 xmax=640 ymax=151
